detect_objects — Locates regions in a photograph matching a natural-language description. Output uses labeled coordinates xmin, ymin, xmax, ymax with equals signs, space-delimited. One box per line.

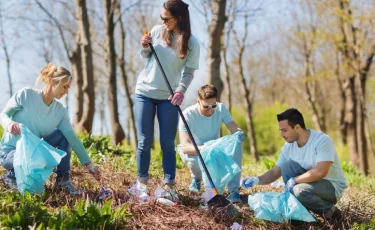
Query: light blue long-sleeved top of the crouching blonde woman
xmin=0 ymin=88 xmax=90 ymax=164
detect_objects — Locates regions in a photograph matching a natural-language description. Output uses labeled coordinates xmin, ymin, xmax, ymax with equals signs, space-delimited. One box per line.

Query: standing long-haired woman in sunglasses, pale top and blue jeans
xmin=135 ymin=0 xmax=200 ymax=201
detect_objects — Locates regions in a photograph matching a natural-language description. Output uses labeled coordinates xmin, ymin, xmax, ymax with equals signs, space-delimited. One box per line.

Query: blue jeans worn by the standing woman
xmin=135 ymin=94 xmax=178 ymax=185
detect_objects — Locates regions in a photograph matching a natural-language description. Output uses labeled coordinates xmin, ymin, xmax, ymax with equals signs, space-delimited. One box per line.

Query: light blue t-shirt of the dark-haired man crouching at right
xmin=276 ymin=129 xmax=348 ymax=200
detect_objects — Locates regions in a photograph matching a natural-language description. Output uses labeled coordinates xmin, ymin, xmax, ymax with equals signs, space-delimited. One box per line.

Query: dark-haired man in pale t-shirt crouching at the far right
xmin=241 ymin=108 xmax=347 ymax=219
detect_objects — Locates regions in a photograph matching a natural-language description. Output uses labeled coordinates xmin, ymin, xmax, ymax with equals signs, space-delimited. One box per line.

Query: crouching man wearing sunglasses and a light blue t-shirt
xmin=178 ymin=85 xmax=245 ymax=202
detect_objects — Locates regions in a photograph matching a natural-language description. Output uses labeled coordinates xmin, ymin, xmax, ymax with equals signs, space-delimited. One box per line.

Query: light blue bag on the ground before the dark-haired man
xmin=248 ymin=192 xmax=315 ymax=223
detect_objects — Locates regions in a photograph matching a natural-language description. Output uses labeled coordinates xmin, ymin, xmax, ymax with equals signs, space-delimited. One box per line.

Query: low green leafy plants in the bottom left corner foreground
xmin=0 ymin=193 xmax=131 ymax=229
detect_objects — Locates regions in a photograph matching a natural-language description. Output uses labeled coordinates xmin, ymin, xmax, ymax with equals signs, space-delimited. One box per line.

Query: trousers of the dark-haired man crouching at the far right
xmin=281 ymin=161 xmax=337 ymax=214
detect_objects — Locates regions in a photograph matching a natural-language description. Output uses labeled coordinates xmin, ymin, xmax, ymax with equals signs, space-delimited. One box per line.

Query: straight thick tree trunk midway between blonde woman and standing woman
xmin=104 ymin=0 xmax=125 ymax=145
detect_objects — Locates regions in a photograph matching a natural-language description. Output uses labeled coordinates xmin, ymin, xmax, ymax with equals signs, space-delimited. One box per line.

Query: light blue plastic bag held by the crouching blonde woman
xmin=13 ymin=125 xmax=66 ymax=194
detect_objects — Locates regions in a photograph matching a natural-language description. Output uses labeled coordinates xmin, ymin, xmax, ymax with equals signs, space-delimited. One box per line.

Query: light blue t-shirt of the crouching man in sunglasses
xmin=179 ymin=103 xmax=233 ymax=145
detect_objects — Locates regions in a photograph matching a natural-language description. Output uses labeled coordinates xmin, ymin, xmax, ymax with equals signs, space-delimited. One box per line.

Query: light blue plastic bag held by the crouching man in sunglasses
xmin=199 ymin=132 xmax=242 ymax=194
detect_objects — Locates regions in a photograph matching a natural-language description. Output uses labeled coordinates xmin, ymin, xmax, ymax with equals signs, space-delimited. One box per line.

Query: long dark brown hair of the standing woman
xmin=163 ymin=0 xmax=191 ymax=59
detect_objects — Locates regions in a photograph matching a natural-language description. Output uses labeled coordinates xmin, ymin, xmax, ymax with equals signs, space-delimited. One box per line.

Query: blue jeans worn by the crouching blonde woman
xmin=3 ymin=129 xmax=72 ymax=180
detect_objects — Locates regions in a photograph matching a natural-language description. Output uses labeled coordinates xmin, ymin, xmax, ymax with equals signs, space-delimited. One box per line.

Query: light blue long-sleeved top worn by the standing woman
xmin=135 ymin=25 xmax=200 ymax=100
